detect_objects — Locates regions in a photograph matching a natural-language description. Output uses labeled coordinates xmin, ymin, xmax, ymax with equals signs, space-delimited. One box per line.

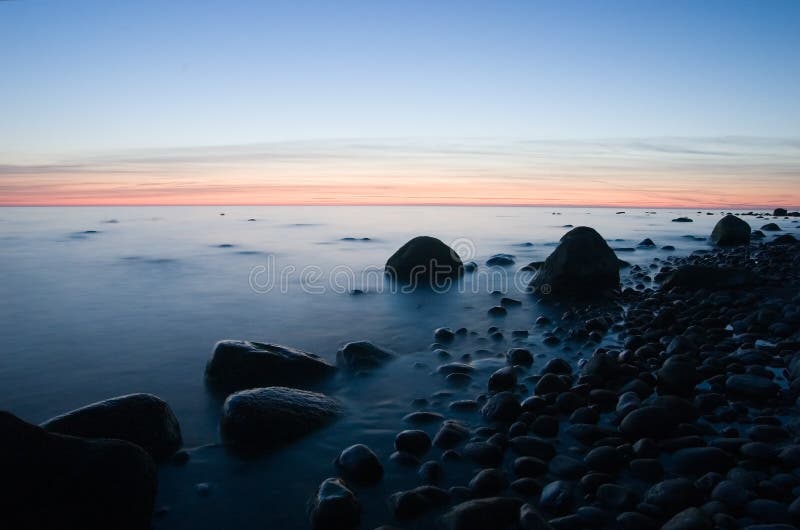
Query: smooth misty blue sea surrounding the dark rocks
xmin=0 ymin=207 xmax=797 ymax=529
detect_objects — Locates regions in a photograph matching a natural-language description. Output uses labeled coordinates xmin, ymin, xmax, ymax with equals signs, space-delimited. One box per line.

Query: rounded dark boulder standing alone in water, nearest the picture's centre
xmin=386 ymin=236 xmax=464 ymax=285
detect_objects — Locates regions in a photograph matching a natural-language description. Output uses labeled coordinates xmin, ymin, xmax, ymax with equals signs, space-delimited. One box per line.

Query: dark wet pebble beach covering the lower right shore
xmin=310 ymin=234 xmax=800 ymax=530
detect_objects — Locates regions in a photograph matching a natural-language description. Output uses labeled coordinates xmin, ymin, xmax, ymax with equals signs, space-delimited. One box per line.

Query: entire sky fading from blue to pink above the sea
xmin=0 ymin=0 xmax=800 ymax=207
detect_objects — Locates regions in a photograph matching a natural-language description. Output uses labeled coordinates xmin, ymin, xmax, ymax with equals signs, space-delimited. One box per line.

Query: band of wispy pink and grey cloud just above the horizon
xmin=0 ymin=137 xmax=800 ymax=207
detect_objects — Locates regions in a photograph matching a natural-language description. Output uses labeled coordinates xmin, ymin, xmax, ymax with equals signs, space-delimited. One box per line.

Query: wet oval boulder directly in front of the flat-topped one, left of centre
xmin=220 ymin=386 xmax=342 ymax=450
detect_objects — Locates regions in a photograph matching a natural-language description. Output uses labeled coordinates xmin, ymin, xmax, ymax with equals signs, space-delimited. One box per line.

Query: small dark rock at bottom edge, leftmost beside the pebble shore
xmin=310 ymin=478 xmax=361 ymax=530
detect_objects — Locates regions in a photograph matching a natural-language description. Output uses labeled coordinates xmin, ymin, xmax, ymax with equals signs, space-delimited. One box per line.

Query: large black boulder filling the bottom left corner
xmin=0 ymin=412 xmax=156 ymax=530
